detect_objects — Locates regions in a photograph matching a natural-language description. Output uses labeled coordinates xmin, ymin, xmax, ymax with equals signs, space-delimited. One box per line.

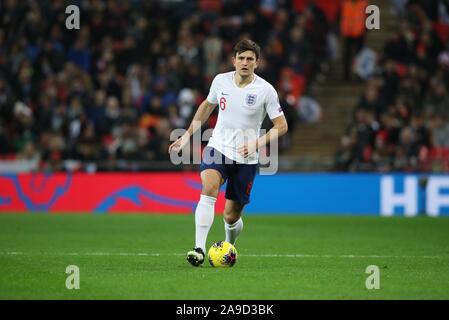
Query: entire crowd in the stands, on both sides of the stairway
xmin=0 ymin=0 xmax=449 ymax=172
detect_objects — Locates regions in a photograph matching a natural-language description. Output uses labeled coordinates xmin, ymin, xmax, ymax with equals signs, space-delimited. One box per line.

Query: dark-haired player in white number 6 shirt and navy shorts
xmin=168 ymin=40 xmax=288 ymax=266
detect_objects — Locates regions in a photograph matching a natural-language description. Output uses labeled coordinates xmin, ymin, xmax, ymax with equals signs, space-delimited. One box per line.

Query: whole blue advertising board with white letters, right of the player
xmin=245 ymin=173 xmax=449 ymax=216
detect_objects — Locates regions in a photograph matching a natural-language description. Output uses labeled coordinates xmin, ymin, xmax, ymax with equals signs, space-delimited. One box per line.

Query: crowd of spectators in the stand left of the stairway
xmin=0 ymin=0 xmax=334 ymax=171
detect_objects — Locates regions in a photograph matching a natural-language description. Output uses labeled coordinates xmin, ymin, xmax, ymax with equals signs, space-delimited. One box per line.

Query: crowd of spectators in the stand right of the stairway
xmin=334 ymin=0 xmax=449 ymax=172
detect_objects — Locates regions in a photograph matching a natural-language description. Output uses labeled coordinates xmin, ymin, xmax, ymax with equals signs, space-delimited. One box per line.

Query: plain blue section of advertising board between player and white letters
xmin=245 ymin=173 xmax=379 ymax=215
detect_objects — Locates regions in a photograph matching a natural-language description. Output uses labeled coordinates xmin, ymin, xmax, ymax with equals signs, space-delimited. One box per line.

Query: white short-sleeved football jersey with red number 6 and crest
xmin=207 ymin=71 xmax=284 ymax=164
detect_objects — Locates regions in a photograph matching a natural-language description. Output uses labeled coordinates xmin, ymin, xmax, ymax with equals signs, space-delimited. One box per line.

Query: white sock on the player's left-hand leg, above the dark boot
xmin=195 ymin=194 xmax=217 ymax=254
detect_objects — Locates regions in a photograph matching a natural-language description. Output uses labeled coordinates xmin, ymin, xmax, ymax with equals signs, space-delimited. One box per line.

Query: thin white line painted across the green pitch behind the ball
xmin=0 ymin=251 xmax=449 ymax=259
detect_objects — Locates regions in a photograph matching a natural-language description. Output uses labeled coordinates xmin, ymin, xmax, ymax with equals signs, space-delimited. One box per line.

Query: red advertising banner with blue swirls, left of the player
xmin=0 ymin=172 xmax=225 ymax=214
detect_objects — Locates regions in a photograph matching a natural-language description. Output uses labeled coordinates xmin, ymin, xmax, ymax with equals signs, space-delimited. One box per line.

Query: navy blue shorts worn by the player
xmin=200 ymin=146 xmax=258 ymax=204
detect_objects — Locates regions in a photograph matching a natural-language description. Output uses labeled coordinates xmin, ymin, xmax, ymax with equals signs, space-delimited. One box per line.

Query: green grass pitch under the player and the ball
xmin=0 ymin=213 xmax=449 ymax=299
